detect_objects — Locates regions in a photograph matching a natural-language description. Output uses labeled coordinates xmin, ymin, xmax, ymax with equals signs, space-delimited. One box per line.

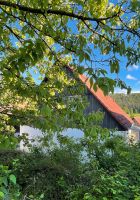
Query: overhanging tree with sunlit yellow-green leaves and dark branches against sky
xmin=0 ymin=0 xmax=140 ymax=133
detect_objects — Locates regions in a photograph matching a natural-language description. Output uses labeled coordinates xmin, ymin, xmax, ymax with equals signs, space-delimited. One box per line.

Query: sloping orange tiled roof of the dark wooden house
xmin=79 ymin=74 xmax=134 ymax=130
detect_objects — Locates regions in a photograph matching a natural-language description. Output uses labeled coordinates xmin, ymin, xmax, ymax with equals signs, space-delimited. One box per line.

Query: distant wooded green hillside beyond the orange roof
xmin=111 ymin=93 xmax=140 ymax=116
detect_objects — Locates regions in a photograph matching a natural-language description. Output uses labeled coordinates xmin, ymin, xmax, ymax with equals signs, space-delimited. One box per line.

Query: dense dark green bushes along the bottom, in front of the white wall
xmin=0 ymin=136 xmax=140 ymax=200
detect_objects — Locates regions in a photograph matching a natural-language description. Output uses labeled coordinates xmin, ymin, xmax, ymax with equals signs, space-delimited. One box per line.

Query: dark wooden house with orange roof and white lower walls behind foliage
xmin=20 ymin=68 xmax=140 ymax=148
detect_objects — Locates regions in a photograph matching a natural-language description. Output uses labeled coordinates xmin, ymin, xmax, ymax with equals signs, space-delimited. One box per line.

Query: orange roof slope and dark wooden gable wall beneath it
xmin=79 ymin=75 xmax=133 ymax=131
